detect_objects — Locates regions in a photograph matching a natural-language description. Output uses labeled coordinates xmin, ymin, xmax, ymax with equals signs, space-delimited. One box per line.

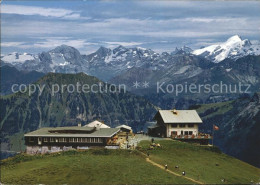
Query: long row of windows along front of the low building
xmin=29 ymin=137 xmax=103 ymax=143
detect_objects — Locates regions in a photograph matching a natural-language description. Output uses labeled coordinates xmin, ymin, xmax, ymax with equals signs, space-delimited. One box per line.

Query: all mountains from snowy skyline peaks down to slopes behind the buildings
xmin=0 ymin=36 xmax=260 ymax=166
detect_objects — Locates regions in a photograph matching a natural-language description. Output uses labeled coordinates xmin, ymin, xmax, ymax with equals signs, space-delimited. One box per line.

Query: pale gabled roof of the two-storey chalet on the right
xmin=154 ymin=110 xmax=202 ymax=123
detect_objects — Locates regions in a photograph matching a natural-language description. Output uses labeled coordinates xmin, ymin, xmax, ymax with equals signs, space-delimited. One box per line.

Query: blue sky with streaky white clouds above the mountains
xmin=1 ymin=0 xmax=260 ymax=54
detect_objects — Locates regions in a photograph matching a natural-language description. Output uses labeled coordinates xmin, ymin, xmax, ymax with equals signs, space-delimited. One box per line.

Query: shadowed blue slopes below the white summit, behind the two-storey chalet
xmin=109 ymin=54 xmax=260 ymax=109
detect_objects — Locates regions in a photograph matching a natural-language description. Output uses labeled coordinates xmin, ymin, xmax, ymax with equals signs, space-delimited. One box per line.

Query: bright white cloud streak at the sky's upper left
xmin=1 ymin=4 xmax=80 ymax=19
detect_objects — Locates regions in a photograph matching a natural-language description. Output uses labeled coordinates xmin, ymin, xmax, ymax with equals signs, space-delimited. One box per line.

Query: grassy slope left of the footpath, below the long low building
xmin=1 ymin=150 xmax=190 ymax=184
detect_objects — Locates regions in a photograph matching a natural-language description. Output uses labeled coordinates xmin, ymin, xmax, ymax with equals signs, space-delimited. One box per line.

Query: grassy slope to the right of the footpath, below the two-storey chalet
xmin=140 ymin=140 xmax=260 ymax=184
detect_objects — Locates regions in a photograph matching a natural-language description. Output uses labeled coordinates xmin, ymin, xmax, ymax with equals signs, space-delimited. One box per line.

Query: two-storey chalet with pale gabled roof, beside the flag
xmin=148 ymin=109 xmax=202 ymax=137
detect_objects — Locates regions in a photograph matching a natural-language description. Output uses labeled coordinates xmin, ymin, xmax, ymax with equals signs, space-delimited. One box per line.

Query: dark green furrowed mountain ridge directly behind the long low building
xmin=0 ymin=73 xmax=156 ymax=152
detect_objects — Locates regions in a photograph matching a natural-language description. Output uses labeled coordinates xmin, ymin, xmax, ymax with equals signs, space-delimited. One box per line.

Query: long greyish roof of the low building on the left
xmin=24 ymin=127 xmax=120 ymax=137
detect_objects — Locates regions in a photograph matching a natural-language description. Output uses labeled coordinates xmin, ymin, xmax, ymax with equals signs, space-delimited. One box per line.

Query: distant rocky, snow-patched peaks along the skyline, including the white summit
xmin=1 ymin=35 xmax=260 ymax=81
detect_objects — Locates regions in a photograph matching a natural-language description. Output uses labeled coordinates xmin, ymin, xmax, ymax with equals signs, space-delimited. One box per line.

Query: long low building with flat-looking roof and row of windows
xmin=24 ymin=124 xmax=120 ymax=154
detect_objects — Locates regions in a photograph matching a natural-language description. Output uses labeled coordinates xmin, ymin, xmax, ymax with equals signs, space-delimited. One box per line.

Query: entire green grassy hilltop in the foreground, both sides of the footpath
xmin=1 ymin=140 xmax=260 ymax=184
